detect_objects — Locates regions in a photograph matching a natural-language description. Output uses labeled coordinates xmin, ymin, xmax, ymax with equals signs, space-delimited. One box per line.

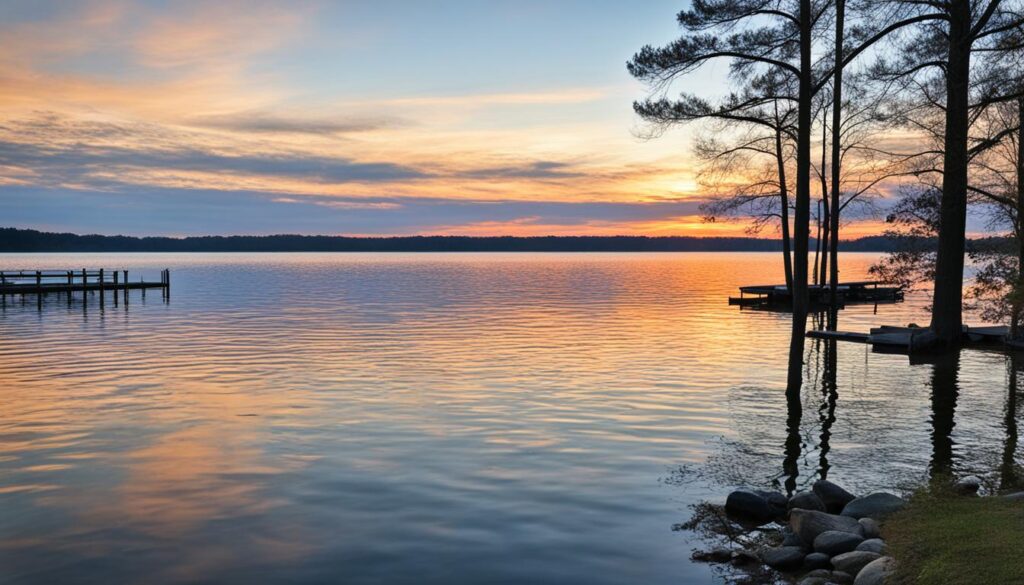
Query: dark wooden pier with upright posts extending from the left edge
xmin=0 ymin=268 xmax=171 ymax=302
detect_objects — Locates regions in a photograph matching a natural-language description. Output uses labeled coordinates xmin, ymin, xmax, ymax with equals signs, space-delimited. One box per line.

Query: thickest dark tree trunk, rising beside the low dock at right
xmin=932 ymin=0 xmax=972 ymax=347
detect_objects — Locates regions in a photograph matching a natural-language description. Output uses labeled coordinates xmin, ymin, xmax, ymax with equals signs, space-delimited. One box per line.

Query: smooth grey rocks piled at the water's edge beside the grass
xmin=693 ymin=476 xmax=1007 ymax=585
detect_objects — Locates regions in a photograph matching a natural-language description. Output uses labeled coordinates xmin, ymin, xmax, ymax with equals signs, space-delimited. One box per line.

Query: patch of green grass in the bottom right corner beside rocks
xmin=883 ymin=492 xmax=1024 ymax=585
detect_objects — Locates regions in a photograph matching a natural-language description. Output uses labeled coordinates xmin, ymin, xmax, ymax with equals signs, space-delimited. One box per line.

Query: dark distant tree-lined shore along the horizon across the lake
xmin=0 ymin=227 xmax=894 ymax=253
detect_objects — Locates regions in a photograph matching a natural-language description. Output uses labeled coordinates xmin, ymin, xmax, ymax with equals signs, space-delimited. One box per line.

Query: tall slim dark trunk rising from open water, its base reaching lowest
xmin=785 ymin=0 xmax=812 ymax=393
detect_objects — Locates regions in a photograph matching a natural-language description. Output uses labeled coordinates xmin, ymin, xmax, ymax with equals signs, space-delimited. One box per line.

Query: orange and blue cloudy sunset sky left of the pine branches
xmin=0 ymin=0 xmax=913 ymax=237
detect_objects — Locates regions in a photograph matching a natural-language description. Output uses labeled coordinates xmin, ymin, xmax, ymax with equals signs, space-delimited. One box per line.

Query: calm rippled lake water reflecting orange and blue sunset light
xmin=0 ymin=253 xmax=1022 ymax=585
